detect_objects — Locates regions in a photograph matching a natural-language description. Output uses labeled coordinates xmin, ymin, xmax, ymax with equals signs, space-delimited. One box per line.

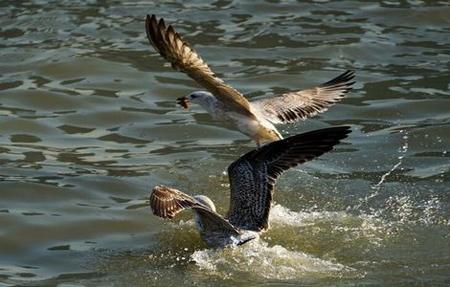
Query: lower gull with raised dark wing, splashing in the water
xmin=150 ymin=126 xmax=350 ymax=247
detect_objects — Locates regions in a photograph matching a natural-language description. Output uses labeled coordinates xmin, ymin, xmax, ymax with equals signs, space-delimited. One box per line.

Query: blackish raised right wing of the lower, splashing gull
xmin=228 ymin=126 xmax=350 ymax=231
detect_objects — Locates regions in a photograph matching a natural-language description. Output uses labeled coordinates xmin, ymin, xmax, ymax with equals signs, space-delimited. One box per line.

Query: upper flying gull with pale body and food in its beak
xmin=145 ymin=15 xmax=355 ymax=147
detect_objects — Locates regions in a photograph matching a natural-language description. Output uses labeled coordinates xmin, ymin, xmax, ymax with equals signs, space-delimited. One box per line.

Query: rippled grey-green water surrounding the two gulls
xmin=0 ymin=0 xmax=450 ymax=286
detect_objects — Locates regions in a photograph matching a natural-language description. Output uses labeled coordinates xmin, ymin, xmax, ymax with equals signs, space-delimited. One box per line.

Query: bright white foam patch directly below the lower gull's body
xmin=191 ymin=240 xmax=357 ymax=280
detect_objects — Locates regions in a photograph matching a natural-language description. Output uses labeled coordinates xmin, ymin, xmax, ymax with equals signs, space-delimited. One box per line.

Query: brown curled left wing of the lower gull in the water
xmin=150 ymin=185 xmax=239 ymax=236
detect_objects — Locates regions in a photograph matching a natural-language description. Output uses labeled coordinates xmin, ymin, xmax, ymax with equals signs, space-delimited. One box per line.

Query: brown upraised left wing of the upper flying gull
xmin=145 ymin=15 xmax=253 ymax=117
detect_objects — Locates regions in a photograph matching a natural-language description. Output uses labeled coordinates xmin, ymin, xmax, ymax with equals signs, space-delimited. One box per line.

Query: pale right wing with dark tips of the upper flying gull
xmin=251 ymin=71 xmax=355 ymax=124
